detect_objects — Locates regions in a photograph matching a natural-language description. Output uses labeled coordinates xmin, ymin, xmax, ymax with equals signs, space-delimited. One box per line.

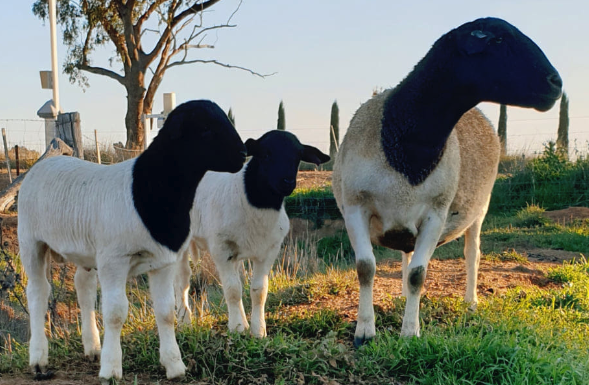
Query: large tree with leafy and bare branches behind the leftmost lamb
xmin=33 ymin=0 xmax=265 ymax=148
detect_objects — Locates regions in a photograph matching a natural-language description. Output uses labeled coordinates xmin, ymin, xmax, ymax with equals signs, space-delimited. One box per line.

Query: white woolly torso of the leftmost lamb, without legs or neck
xmin=18 ymin=156 xmax=148 ymax=262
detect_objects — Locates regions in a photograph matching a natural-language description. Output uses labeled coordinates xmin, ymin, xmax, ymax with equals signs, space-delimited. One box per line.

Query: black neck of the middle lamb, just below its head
xmin=243 ymin=158 xmax=284 ymax=211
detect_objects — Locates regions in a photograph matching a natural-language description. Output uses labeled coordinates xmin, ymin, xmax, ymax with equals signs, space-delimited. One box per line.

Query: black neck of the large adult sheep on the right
xmin=381 ymin=54 xmax=478 ymax=186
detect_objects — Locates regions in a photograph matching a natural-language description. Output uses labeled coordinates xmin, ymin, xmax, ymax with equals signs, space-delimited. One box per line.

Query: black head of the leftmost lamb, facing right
xmin=152 ymin=100 xmax=246 ymax=173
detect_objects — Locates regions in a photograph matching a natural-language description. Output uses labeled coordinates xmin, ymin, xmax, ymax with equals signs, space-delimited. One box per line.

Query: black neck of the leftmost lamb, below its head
xmin=132 ymin=142 xmax=207 ymax=251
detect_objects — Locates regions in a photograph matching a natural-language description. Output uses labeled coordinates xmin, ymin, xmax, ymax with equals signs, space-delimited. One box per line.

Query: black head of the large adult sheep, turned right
xmin=444 ymin=18 xmax=562 ymax=111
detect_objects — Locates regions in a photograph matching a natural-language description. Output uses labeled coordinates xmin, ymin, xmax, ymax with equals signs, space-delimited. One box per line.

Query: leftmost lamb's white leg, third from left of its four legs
xmin=96 ymin=255 xmax=130 ymax=380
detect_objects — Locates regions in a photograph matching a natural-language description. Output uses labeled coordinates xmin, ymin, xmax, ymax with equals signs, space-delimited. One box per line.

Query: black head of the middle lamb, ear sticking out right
xmin=245 ymin=130 xmax=330 ymax=198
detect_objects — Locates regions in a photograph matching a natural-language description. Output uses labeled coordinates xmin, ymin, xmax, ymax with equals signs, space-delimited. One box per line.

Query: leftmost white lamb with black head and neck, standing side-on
xmin=18 ymin=100 xmax=246 ymax=380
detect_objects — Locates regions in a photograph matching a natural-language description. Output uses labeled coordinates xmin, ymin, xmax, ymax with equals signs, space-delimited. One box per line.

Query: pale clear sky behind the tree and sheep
xmin=0 ymin=0 xmax=589 ymax=153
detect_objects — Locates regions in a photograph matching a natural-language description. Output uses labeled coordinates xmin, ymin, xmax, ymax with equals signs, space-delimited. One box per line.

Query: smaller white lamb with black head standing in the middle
xmin=175 ymin=130 xmax=330 ymax=337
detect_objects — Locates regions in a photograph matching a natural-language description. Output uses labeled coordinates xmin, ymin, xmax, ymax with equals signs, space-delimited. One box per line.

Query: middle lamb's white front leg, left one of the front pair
xmin=215 ymin=253 xmax=249 ymax=332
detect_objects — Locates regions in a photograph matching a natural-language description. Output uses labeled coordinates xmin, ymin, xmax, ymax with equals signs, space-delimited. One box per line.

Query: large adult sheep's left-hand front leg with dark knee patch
xmin=344 ymin=206 xmax=376 ymax=347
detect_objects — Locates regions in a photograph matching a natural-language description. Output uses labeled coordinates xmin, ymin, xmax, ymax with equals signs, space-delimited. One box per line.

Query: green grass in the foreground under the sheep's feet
xmin=0 ymin=261 xmax=589 ymax=385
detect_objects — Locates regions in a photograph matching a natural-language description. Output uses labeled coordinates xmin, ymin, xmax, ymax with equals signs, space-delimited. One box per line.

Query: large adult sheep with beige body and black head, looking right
xmin=333 ymin=18 xmax=562 ymax=346
